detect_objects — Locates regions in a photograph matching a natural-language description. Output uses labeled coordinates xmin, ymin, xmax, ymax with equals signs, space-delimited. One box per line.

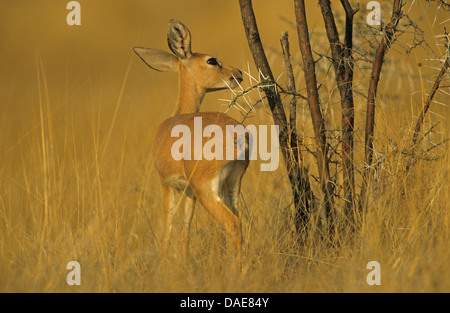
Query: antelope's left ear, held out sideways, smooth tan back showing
xmin=133 ymin=47 xmax=178 ymax=72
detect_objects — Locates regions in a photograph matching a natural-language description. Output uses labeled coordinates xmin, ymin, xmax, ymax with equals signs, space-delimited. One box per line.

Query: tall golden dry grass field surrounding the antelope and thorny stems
xmin=0 ymin=1 xmax=450 ymax=292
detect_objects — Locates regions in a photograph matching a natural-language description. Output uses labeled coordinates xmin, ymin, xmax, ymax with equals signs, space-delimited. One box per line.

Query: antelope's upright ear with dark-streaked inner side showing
xmin=167 ymin=19 xmax=192 ymax=60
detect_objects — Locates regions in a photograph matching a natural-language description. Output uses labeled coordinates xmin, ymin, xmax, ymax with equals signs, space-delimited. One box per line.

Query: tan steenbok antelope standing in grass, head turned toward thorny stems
xmin=134 ymin=20 xmax=249 ymax=269
